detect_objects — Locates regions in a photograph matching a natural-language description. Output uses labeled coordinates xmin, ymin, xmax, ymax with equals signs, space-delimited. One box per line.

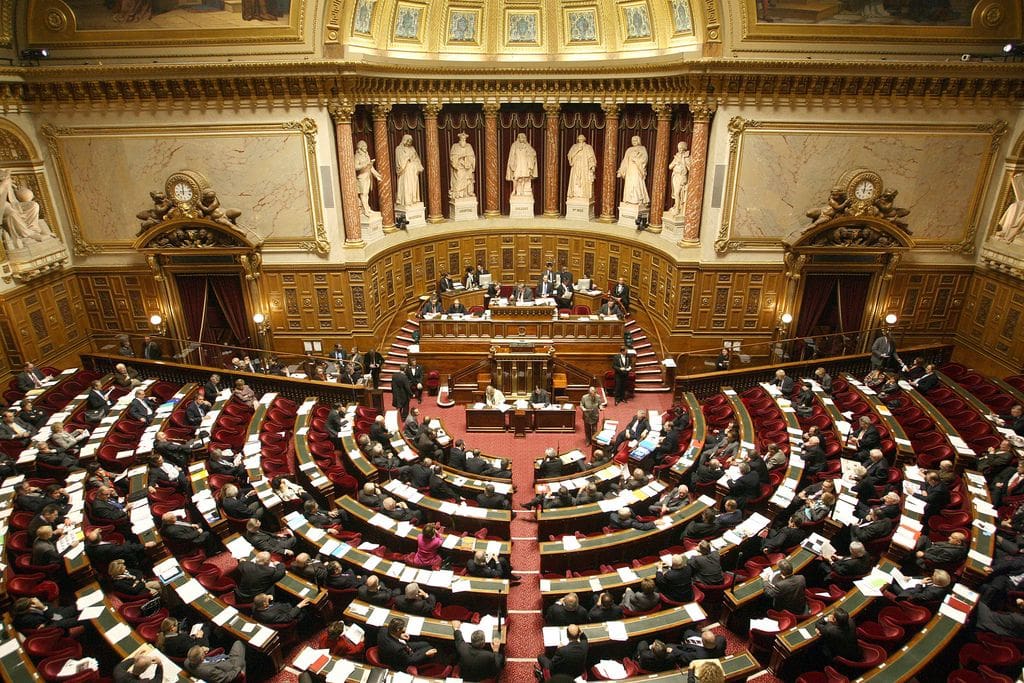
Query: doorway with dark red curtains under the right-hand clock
xmin=794 ymin=272 xmax=873 ymax=359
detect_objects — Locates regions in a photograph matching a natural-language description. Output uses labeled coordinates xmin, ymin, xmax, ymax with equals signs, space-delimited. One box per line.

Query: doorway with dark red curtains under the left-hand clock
xmin=174 ymin=273 xmax=252 ymax=368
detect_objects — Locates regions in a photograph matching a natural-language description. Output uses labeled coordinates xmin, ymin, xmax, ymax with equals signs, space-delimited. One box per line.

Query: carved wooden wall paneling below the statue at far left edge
xmin=0 ymin=271 xmax=89 ymax=375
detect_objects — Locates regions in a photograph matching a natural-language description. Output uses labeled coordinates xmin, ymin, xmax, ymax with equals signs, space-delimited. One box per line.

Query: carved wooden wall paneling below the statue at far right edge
xmin=956 ymin=269 xmax=1024 ymax=375
